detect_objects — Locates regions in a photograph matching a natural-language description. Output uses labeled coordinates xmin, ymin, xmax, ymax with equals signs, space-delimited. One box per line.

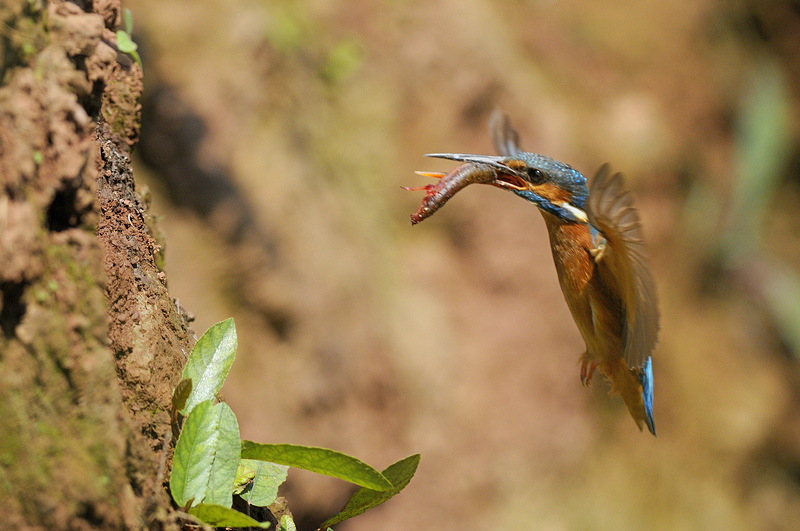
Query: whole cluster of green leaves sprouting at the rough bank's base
xmin=169 ymin=319 xmax=419 ymax=531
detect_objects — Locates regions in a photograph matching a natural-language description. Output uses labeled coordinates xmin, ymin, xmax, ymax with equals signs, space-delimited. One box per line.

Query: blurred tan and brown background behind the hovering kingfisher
xmin=130 ymin=0 xmax=800 ymax=531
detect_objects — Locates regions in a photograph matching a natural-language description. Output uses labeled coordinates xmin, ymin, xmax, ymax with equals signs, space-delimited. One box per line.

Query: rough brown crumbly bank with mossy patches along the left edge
xmin=0 ymin=0 xmax=194 ymax=529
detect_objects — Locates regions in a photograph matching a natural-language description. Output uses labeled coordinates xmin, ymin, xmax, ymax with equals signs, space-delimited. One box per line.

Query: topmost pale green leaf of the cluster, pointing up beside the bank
xmin=181 ymin=318 xmax=237 ymax=415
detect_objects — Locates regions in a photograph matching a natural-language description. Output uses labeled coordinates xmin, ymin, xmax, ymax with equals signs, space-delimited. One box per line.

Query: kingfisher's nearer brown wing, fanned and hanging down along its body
xmin=586 ymin=164 xmax=658 ymax=369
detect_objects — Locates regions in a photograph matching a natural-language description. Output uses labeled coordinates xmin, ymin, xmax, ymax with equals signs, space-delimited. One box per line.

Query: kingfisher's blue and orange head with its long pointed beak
xmin=425 ymin=151 xmax=589 ymax=223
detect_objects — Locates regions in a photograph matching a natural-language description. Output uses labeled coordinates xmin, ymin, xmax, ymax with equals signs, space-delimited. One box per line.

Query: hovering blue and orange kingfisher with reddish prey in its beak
xmin=406 ymin=111 xmax=659 ymax=435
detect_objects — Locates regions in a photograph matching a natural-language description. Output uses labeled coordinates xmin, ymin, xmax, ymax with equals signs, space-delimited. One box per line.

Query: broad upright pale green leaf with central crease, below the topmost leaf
xmin=169 ymin=400 xmax=240 ymax=507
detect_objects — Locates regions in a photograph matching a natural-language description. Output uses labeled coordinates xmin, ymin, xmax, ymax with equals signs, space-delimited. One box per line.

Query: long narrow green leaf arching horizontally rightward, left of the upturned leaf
xmin=242 ymin=441 xmax=393 ymax=491
